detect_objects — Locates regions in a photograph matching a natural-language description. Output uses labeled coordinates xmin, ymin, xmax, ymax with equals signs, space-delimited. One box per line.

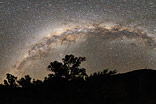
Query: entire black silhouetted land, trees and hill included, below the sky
xmin=0 ymin=55 xmax=156 ymax=104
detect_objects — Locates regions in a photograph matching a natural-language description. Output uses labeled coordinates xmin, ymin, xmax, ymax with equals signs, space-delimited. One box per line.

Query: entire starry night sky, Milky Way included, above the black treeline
xmin=0 ymin=0 xmax=156 ymax=79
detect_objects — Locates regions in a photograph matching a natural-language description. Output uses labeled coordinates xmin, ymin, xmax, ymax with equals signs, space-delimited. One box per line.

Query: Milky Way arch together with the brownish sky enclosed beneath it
xmin=11 ymin=24 xmax=156 ymax=78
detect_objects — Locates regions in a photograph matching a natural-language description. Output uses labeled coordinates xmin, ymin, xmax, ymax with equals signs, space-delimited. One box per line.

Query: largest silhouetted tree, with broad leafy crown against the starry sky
xmin=48 ymin=55 xmax=87 ymax=80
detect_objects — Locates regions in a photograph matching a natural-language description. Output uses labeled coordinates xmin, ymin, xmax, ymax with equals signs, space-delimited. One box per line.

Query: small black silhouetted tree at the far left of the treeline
xmin=4 ymin=74 xmax=18 ymax=88
